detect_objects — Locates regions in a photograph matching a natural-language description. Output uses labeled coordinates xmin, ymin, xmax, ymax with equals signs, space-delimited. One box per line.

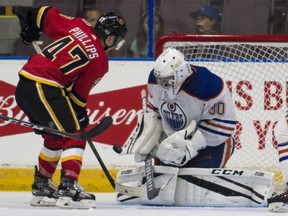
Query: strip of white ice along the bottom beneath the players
xmin=0 ymin=192 xmax=275 ymax=216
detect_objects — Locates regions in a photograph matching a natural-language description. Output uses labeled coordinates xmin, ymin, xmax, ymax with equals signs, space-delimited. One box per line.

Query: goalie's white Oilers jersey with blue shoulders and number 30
xmin=148 ymin=66 xmax=236 ymax=146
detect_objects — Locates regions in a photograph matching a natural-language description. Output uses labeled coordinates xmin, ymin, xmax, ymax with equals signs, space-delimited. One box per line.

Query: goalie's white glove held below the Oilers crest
xmin=156 ymin=120 xmax=206 ymax=166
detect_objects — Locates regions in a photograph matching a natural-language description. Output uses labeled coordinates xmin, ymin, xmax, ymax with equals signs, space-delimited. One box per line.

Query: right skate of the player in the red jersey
xmin=56 ymin=177 xmax=96 ymax=209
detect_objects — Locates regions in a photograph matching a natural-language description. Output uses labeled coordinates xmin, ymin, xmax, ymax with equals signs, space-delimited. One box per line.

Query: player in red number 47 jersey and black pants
xmin=15 ymin=6 xmax=127 ymax=208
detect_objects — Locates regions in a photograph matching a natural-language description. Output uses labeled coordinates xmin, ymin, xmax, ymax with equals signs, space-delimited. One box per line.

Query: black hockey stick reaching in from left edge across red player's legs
xmin=0 ymin=115 xmax=113 ymax=140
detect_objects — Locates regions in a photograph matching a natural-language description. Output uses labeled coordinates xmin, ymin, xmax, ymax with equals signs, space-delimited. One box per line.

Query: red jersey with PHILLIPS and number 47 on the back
xmin=20 ymin=7 xmax=108 ymax=105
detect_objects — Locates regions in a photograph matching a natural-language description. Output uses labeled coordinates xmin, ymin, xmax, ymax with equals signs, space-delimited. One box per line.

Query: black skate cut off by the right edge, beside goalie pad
xmin=267 ymin=189 xmax=288 ymax=212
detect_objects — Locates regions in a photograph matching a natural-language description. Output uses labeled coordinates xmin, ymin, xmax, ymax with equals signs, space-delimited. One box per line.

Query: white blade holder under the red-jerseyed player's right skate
xmin=56 ymin=197 xmax=96 ymax=209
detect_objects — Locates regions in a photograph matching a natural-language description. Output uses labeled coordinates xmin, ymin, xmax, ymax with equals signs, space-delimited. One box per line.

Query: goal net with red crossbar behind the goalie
xmin=156 ymin=34 xmax=288 ymax=184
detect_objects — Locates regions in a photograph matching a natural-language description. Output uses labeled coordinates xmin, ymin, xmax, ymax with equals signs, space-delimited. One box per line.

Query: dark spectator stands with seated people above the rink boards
xmin=0 ymin=0 xmax=288 ymax=58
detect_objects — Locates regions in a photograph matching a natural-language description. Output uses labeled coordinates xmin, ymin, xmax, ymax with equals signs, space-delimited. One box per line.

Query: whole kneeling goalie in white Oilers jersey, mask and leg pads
xmin=116 ymin=48 xmax=273 ymax=207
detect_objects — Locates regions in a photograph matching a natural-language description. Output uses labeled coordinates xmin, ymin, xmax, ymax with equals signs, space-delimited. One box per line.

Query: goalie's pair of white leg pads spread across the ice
xmin=116 ymin=166 xmax=274 ymax=207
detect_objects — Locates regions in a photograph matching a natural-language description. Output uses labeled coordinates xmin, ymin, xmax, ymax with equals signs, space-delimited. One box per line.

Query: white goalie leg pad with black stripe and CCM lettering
xmin=175 ymin=168 xmax=274 ymax=207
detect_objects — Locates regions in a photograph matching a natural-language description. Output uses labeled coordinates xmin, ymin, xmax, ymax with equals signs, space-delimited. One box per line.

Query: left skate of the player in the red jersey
xmin=30 ymin=166 xmax=58 ymax=207
